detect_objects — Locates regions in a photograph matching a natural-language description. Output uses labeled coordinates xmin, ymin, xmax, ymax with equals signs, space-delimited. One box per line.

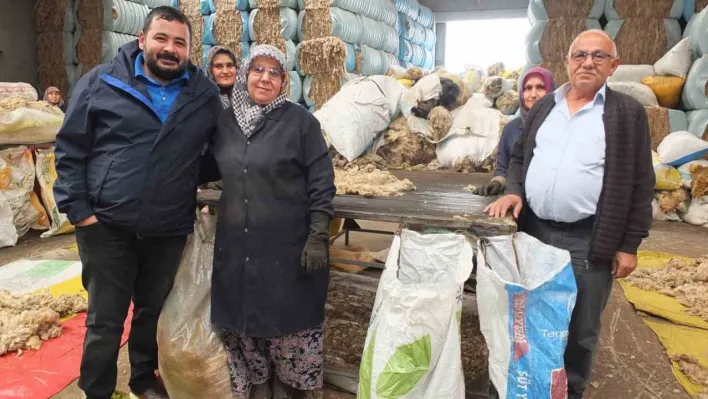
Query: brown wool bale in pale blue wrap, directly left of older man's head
xmin=526 ymin=18 xmax=600 ymax=64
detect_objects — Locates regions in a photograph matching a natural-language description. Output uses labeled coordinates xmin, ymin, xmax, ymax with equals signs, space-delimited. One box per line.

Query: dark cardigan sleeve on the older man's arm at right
xmin=619 ymin=109 xmax=656 ymax=255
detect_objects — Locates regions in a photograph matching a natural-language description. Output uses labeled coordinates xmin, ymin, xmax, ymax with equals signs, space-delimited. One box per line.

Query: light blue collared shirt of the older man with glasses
xmin=525 ymin=84 xmax=606 ymax=223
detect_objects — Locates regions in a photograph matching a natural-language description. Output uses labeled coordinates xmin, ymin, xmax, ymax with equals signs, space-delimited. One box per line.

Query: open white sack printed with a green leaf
xmin=357 ymin=230 xmax=473 ymax=399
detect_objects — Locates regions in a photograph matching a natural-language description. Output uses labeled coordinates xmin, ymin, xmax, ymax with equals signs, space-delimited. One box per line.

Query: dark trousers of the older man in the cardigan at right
xmin=525 ymin=210 xmax=612 ymax=399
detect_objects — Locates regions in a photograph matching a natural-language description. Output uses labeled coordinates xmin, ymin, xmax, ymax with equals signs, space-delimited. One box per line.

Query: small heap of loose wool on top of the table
xmin=334 ymin=165 xmax=415 ymax=197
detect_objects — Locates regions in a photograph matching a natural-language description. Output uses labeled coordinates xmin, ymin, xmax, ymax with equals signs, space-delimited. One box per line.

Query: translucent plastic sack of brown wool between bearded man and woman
xmin=157 ymin=214 xmax=242 ymax=399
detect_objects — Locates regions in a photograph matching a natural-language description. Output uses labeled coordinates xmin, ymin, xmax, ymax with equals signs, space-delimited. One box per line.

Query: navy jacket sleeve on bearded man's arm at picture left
xmin=54 ymin=71 xmax=95 ymax=224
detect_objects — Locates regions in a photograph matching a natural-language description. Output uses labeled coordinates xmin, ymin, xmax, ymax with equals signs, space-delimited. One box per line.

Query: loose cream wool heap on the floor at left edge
xmin=0 ymin=290 xmax=87 ymax=355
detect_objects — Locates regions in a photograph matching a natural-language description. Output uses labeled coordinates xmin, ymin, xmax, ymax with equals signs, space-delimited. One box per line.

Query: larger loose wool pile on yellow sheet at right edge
xmin=627 ymin=256 xmax=708 ymax=321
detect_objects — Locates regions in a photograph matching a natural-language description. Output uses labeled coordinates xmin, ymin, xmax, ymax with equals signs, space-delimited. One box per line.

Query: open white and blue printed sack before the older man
xmin=477 ymin=233 xmax=577 ymax=399
